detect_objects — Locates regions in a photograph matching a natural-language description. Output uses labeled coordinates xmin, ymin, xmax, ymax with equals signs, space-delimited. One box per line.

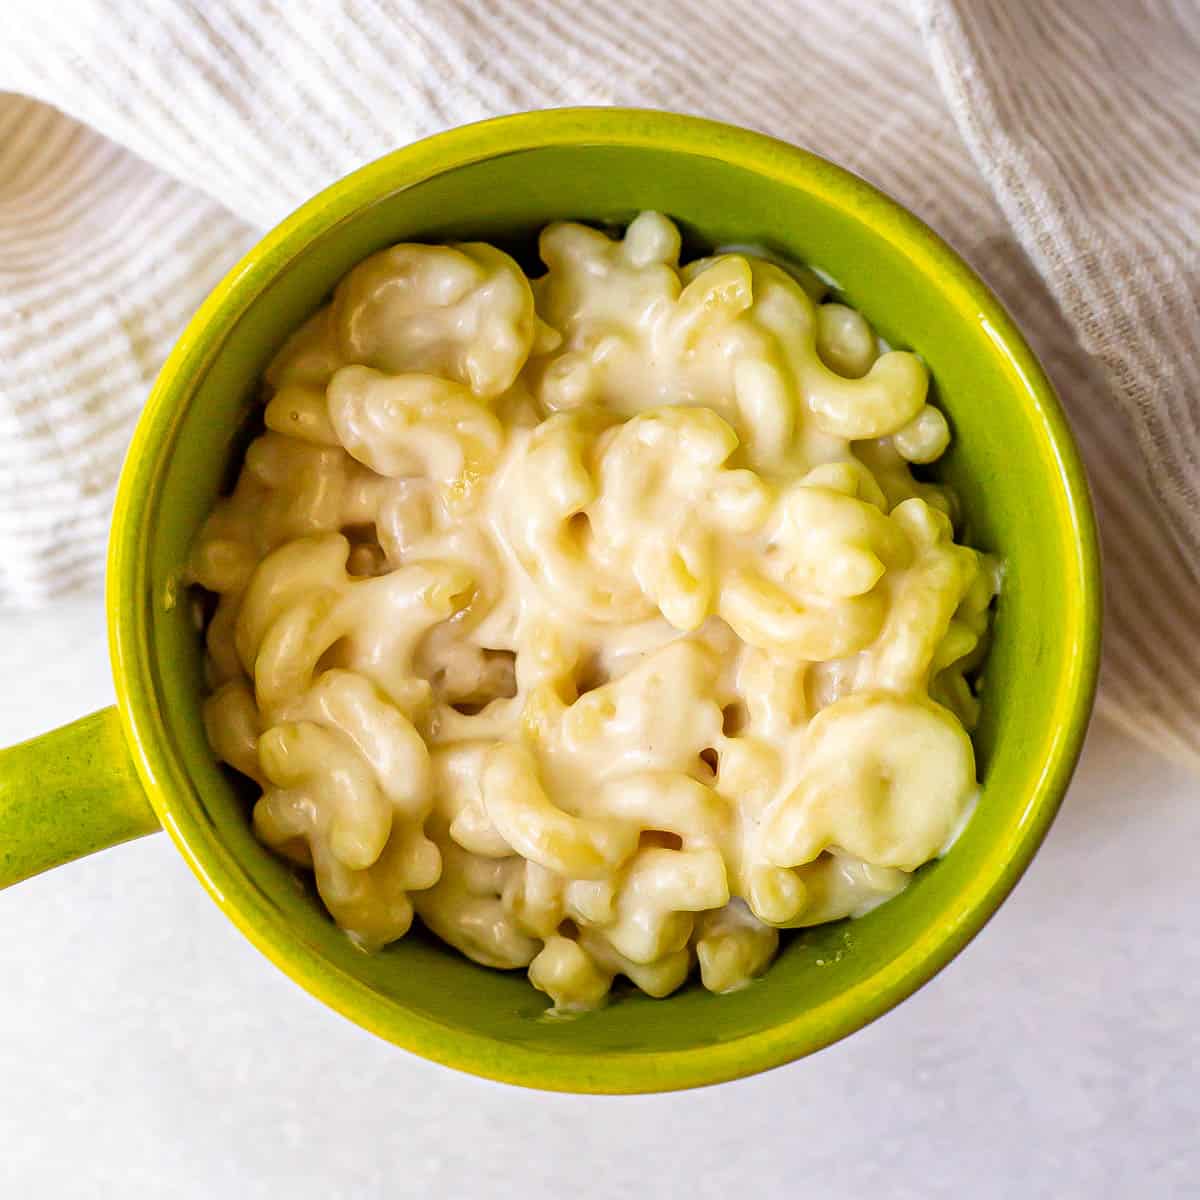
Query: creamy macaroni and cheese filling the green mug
xmin=190 ymin=212 xmax=998 ymax=1010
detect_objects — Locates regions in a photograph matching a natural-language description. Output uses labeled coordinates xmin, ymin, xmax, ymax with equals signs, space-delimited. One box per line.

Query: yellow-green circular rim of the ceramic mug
xmin=106 ymin=108 xmax=1102 ymax=1092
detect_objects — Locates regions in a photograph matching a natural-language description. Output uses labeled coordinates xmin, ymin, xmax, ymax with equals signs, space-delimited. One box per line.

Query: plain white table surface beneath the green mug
xmin=0 ymin=595 xmax=1200 ymax=1200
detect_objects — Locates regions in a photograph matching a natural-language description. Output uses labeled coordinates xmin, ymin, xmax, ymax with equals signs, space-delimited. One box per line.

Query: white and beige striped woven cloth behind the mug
xmin=0 ymin=0 xmax=1200 ymax=764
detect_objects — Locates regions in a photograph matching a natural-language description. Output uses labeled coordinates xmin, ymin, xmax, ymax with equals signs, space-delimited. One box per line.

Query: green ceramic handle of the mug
xmin=0 ymin=708 xmax=161 ymax=888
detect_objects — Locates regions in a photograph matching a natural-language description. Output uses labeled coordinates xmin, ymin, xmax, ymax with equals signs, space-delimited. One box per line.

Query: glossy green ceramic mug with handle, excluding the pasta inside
xmin=0 ymin=109 xmax=1100 ymax=1092
